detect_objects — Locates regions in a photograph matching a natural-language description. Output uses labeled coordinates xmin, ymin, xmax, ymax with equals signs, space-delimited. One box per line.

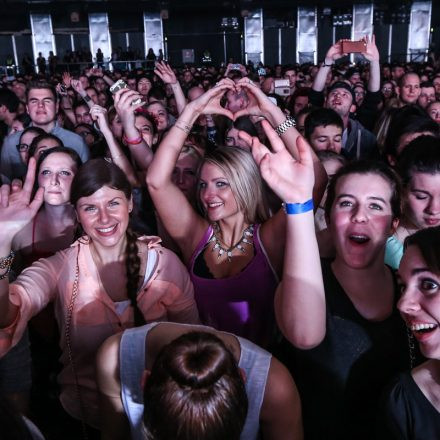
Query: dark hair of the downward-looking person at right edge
xmin=397 ymin=135 xmax=440 ymax=185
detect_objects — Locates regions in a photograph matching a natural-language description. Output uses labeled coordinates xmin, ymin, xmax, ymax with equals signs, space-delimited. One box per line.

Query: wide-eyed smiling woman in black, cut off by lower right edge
xmin=377 ymin=227 xmax=440 ymax=440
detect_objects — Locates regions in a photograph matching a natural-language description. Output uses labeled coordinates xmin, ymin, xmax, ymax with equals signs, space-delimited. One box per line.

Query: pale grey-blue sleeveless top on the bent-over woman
xmin=119 ymin=322 xmax=272 ymax=440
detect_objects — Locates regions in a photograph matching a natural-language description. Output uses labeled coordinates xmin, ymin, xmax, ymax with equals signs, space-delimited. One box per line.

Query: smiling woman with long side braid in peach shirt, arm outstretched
xmin=0 ymin=158 xmax=198 ymax=429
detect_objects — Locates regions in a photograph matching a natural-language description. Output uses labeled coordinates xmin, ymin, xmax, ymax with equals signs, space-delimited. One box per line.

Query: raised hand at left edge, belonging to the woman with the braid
xmin=0 ymin=157 xmax=44 ymax=242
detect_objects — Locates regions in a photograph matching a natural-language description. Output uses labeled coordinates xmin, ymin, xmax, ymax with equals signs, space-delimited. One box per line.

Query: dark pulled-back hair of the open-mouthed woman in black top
xmin=324 ymin=160 xmax=402 ymax=218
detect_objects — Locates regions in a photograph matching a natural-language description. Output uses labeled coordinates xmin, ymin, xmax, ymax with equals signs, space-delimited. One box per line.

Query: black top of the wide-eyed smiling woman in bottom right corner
xmin=377 ymin=373 xmax=440 ymax=440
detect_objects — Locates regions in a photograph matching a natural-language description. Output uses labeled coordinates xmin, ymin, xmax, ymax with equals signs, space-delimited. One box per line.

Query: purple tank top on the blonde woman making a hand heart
xmin=189 ymin=225 xmax=278 ymax=347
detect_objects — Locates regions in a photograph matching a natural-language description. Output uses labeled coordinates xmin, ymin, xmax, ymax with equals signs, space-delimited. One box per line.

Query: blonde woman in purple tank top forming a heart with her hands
xmin=147 ymin=78 xmax=323 ymax=347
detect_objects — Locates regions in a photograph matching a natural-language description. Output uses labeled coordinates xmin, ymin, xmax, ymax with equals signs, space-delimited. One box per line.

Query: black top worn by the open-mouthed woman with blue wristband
xmin=279 ymin=260 xmax=409 ymax=440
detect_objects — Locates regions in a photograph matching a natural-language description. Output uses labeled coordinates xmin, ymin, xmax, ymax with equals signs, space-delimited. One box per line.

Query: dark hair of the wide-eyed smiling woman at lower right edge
xmin=403 ymin=226 xmax=440 ymax=273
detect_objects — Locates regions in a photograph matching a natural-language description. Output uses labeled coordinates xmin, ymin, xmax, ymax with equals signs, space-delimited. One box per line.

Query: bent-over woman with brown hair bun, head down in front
xmin=97 ymin=323 xmax=303 ymax=440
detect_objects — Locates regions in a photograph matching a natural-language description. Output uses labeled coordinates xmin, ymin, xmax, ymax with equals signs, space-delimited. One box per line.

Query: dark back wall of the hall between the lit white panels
xmin=0 ymin=0 xmax=440 ymax=65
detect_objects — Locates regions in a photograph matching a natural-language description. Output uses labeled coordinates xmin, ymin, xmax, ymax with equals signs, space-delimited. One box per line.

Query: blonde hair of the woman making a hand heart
xmin=199 ymin=147 xmax=269 ymax=223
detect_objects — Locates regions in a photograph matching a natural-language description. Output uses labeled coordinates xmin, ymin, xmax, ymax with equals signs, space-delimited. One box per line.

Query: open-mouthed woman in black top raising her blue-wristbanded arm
xmin=276 ymin=162 xmax=410 ymax=439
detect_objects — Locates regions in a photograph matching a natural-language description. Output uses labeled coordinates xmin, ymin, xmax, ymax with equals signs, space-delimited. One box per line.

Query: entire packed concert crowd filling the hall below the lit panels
xmin=0 ymin=36 xmax=440 ymax=440
